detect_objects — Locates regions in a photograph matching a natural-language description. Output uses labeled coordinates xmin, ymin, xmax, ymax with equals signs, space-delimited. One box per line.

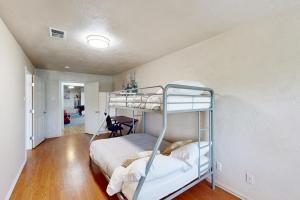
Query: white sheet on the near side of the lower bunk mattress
xmin=122 ymin=156 xmax=209 ymax=200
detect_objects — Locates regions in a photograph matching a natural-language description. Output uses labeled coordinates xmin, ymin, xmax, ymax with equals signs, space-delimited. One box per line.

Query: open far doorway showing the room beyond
xmin=62 ymin=83 xmax=85 ymax=136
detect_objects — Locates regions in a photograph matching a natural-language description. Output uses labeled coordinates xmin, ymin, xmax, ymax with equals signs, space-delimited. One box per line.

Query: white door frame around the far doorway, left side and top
xmin=58 ymin=81 xmax=86 ymax=136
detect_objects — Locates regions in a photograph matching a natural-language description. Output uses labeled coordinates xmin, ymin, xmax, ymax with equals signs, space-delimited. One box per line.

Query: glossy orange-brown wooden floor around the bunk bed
xmin=11 ymin=134 xmax=238 ymax=200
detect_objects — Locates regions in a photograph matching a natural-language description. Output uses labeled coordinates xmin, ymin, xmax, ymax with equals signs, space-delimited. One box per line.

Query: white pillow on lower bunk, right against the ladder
xmin=170 ymin=141 xmax=209 ymax=166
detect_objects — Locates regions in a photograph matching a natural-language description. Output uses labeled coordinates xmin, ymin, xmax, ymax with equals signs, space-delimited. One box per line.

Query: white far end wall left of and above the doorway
xmin=36 ymin=69 xmax=112 ymax=138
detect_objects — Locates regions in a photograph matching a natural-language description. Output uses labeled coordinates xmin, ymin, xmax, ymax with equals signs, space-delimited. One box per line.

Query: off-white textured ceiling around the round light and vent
xmin=0 ymin=0 xmax=300 ymax=75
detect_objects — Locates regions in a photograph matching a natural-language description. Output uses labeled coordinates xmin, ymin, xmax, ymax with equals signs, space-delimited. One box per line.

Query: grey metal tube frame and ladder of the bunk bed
xmin=91 ymin=84 xmax=215 ymax=200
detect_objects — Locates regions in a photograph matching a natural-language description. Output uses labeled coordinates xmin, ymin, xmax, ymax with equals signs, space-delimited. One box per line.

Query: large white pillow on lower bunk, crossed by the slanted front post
xmin=123 ymin=154 xmax=191 ymax=182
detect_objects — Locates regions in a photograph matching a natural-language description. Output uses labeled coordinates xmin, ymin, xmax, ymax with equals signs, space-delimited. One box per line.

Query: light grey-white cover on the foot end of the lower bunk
xmin=90 ymin=133 xmax=169 ymax=177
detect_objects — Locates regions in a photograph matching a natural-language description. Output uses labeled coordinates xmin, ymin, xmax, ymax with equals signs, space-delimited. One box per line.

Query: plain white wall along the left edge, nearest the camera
xmin=0 ymin=18 xmax=33 ymax=199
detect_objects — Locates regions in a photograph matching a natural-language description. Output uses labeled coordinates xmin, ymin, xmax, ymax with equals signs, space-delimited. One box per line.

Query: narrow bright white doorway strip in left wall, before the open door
xmin=25 ymin=70 xmax=33 ymax=149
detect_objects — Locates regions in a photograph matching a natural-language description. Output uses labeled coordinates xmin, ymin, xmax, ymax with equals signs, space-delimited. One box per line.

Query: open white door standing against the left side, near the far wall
xmin=33 ymin=76 xmax=46 ymax=148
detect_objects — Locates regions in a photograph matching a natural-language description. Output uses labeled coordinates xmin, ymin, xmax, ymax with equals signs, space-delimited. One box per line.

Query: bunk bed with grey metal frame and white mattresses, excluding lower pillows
xmin=90 ymin=84 xmax=215 ymax=200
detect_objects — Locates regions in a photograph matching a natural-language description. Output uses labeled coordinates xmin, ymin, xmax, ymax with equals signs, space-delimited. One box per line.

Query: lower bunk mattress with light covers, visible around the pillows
xmin=90 ymin=133 xmax=209 ymax=200
